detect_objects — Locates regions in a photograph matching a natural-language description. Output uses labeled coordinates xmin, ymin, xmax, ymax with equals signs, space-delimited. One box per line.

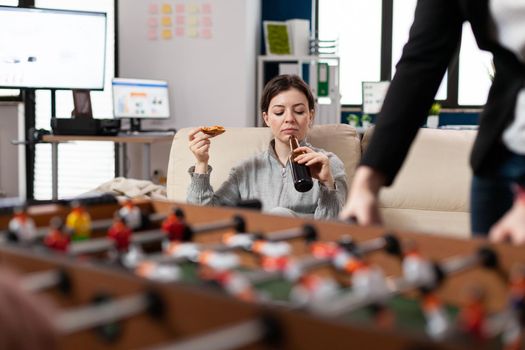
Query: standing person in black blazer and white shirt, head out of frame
xmin=340 ymin=0 xmax=525 ymax=243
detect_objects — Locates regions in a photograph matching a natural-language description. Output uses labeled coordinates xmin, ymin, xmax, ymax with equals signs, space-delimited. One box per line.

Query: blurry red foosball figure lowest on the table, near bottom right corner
xmin=459 ymin=286 xmax=487 ymax=339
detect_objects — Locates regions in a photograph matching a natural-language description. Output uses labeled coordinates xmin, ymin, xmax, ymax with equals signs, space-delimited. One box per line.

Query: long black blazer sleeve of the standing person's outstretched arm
xmin=361 ymin=0 xmax=463 ymax=185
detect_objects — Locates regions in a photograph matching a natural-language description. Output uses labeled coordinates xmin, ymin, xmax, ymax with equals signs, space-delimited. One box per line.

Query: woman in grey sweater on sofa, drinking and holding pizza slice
xmin=187 ymin=75 xmax=347 ymax=219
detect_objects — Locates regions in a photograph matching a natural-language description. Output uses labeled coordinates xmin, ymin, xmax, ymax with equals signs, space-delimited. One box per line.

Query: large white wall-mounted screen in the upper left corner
xmin=0 ymin=6 xmax=107 ymax=90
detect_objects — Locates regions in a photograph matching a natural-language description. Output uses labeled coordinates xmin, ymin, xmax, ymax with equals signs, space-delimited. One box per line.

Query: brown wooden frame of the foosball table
xmin=0 ymin=201 xmax=525 ymax=349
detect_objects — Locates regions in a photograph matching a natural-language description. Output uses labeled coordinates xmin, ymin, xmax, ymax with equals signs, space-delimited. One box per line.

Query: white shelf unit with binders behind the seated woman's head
xmin=255 ymin=55 xmax=341 ymax=126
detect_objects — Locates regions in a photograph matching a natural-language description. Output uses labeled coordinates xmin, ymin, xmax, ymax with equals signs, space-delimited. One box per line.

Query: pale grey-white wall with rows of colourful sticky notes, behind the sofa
xmin=118 ymin=0 xmax=261 ymax=177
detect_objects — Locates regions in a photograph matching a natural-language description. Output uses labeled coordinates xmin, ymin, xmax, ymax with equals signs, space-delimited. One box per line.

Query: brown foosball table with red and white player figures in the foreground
xmin=0 ymin=197 xmax=525 ymax=350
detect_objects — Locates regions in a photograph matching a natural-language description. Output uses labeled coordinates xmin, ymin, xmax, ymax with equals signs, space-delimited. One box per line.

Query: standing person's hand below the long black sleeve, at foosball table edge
xmin=339 ymin=166 xmax=385 ymax=225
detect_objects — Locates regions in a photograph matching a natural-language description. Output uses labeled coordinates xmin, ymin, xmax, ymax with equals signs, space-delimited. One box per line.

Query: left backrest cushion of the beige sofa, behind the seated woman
xmin=167 ymin=124 xmax=361 ymax=202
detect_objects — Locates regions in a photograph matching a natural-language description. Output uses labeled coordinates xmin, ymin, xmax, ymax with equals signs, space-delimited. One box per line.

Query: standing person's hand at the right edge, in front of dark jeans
xmin=489 ymin=199 xmax=525 ymax=244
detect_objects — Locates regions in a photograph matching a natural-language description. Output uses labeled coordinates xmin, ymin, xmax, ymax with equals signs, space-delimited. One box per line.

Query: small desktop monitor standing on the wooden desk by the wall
xmin=111 ymin=78 xmax=170 ymax=131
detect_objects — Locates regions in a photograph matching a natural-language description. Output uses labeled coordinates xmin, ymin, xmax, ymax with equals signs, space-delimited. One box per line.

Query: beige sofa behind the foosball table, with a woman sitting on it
xmin=167 ymin=124 xmax=475 ymax=237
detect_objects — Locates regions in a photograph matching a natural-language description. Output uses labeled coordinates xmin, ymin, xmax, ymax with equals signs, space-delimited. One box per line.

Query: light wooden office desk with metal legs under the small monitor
xmin=42 ymin=133 xmax=174 ymax=200
